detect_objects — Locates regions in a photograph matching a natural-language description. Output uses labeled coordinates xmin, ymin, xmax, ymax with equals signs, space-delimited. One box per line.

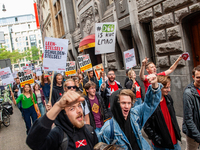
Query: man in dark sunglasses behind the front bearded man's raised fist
xmin=63 ymin=79 xmax=90 ymax=124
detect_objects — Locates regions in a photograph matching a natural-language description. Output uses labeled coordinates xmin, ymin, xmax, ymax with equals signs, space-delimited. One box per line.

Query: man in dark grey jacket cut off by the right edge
xmin=182 ymin=65 xmax=200 ymax=150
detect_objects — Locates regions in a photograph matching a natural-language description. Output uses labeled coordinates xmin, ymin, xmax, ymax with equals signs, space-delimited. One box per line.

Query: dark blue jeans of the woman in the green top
xmin=23 ymin=105 xmax=37 ymax=134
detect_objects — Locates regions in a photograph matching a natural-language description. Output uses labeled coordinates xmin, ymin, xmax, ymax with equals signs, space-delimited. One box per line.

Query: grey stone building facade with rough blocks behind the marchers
xmin=38 ymin=0 xmax=200 ymax=116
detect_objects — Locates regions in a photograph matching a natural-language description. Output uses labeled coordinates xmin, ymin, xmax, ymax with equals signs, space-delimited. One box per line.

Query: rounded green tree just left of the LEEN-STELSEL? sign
xmin=25 ymin=46 xmax=42 ymax=63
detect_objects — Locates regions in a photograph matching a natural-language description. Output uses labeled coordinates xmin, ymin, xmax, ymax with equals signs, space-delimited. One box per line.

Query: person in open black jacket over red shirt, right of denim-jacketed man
xmin=144 ymin=75 xmax=181 ymax=150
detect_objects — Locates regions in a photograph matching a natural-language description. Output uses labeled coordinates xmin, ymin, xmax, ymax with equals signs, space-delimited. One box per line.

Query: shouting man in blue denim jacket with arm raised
xmin=98 ymin=74 xmax=163 ymax=150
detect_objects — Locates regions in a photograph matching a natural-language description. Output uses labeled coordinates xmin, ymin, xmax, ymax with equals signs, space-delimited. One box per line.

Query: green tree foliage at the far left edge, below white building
xmin=0 ymin=47 xmax=25 ymax=63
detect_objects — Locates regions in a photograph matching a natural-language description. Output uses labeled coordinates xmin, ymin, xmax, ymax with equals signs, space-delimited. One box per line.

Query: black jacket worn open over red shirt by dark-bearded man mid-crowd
xmin=100 ymin=80 xmax=122 ymax=109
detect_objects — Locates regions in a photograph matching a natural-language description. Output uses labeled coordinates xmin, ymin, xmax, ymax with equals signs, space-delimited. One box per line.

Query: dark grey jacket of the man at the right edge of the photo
xmin=182 ymin=82 xmax=200 ymax=143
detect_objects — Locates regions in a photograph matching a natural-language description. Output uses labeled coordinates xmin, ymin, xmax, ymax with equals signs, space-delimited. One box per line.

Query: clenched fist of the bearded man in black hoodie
xmin=56 ymin=90 xmax=85 ymax=109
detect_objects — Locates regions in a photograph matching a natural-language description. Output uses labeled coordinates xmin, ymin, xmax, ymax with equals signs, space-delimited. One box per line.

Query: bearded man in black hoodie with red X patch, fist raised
xmin=26 ymin=90 xmax=98 ymax=150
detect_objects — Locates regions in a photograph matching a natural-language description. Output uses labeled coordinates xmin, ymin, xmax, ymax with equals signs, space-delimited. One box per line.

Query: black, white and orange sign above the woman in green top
xmin=18 ymin=66 xmax=34 ymax=87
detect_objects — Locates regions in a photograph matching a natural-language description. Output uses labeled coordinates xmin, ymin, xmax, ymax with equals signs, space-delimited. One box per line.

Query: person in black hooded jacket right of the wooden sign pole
xmin=51 ymin=73 xmax=64 ymax=106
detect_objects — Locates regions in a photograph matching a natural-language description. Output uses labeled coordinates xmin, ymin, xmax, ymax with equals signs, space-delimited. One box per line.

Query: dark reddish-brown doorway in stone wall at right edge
xmin=188 ymin=13 xmax=200 ymax=67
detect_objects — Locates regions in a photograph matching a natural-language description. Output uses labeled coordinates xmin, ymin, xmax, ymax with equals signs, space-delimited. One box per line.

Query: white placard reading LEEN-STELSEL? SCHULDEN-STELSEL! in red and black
xmin=43 ymin=37 xmax=68 ymax=71
